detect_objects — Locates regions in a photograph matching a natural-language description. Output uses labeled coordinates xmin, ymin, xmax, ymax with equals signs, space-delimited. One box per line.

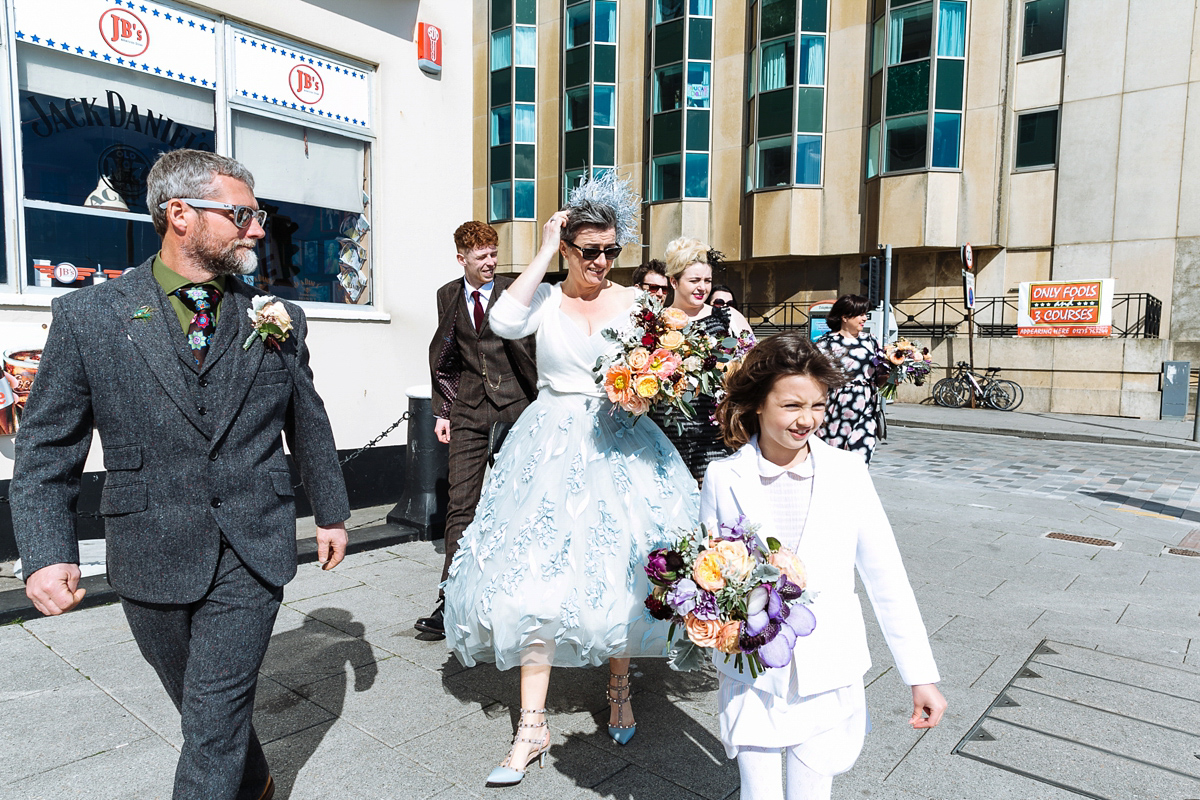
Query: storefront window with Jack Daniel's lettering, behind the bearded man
xmin=17 ymin=44 xmax=215 ymax=288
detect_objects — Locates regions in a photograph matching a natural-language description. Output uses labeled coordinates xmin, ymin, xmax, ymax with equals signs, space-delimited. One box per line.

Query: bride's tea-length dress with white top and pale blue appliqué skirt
xmin=445 ymin=284 xmax=700 ymax=669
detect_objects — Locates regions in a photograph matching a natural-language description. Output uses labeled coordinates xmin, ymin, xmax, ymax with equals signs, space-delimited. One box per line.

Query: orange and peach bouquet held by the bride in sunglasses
xmin=595 ymin=295 xmax=744 ymax=419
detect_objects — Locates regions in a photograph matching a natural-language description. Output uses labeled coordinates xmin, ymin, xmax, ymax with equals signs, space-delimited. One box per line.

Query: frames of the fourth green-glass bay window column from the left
xmin=745 ymin=0 xmax=833 ymax=193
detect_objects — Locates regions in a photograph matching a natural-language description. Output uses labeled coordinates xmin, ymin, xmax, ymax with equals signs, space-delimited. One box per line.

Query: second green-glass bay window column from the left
xmin=563 ymin=0 xmax=617 ymax=193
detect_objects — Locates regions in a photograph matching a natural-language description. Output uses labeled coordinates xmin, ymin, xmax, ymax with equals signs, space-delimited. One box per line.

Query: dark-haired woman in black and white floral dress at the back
xmin=816 ymin=294 xmax=882 ymax=464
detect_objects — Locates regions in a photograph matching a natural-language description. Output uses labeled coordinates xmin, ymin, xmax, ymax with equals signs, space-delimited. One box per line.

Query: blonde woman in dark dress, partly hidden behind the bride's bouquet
xmin=650 ymin=237 xmax=752 ymax=483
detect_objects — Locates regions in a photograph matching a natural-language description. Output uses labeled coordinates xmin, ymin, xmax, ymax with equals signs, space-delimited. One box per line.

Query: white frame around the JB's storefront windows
xmin=0 ymin=0 xmax=374 ymax=311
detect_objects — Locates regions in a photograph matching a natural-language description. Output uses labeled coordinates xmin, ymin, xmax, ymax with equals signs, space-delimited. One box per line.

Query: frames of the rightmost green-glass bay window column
xmin=862 ymin=0 xmax=972 ymax=181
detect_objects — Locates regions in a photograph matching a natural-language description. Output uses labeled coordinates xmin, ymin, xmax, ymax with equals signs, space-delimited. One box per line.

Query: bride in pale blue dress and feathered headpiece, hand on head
xmin=445 ymin=178 xmax=700 ymax=784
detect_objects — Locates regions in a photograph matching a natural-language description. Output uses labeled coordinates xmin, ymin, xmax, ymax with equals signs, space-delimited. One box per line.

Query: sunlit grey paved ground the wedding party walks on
xmin=0 ymin=428 xmax=1200 ymax=800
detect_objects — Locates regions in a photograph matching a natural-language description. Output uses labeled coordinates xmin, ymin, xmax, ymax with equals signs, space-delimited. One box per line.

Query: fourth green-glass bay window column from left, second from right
xmin=754 ymin=0 xmax=829 ymax=188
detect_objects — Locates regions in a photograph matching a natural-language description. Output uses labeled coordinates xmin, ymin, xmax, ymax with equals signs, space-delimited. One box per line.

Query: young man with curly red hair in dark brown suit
xmin=415 ymin=219 xmax=538 ymax=638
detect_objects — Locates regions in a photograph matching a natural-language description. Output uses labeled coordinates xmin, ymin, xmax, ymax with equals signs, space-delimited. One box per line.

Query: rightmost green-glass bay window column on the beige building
xmin=866 ymin=0 xmax=967 ymax=178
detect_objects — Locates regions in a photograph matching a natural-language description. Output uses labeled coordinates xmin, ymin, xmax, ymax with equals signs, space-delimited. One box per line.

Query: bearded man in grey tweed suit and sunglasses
xmin=11 ymin=150 xmax=349 ymax=800
